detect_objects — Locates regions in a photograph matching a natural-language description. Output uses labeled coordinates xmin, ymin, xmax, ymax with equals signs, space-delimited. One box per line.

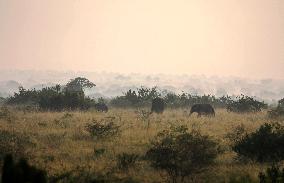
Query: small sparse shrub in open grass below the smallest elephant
xmin=86 ymin=118 xmax=120 ymax=139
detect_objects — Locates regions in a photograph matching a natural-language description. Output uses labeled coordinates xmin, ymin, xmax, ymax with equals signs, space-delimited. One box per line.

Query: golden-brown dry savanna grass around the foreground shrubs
xmin=0 ymin=108 xmax=284 ymax=182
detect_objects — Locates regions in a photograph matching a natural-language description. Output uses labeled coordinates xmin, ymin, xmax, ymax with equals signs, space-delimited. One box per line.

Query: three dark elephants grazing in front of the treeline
xmin=95 ymin=97 xmax=215 ymax=117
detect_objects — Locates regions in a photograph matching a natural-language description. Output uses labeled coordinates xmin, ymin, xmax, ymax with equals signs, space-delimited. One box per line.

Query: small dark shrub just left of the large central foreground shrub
xmin=117 ymin=153 xmax=139 ymax=170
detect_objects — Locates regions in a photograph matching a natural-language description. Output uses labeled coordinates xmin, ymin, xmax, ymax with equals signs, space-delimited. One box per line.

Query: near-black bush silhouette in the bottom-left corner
xmin=2 ymin=154 xmax=47 ymax=183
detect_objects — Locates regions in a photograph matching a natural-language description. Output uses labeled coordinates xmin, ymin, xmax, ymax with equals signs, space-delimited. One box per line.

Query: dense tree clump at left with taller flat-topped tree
xmin=7 ymin=78 xmax=95 ymax=111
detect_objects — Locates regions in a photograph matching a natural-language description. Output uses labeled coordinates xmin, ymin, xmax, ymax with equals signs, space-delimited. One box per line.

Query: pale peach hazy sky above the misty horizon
xmin=0 ymin=0 xmax=284 ymax=78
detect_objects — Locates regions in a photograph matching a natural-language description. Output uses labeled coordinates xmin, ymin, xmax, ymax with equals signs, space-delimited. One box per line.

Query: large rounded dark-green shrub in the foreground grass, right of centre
xmin=145 ymin=126 xmax=218 ymax=182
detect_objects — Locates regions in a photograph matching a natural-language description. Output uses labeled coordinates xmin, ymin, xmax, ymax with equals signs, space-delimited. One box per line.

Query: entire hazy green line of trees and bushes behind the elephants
xmin=6 ymin=77 xmax=267 ymax=112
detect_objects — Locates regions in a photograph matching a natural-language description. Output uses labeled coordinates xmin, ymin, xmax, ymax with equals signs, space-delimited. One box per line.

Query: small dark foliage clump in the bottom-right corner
xmin=258 ymin=164 xmax=284 ymax=183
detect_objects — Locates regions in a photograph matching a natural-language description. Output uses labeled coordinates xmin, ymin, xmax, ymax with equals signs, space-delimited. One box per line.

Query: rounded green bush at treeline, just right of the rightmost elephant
xmin=227 ymin=95 xmax=267 ymax=113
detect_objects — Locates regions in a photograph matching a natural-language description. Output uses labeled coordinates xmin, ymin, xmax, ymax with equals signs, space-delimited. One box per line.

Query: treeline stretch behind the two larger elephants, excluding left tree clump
xmin=110 ymin=87 xmax=267 ymax=113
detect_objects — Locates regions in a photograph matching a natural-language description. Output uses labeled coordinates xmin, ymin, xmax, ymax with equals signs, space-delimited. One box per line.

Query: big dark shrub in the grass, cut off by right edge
xmin=233 ymin=123 xmax=284 ymax=162
